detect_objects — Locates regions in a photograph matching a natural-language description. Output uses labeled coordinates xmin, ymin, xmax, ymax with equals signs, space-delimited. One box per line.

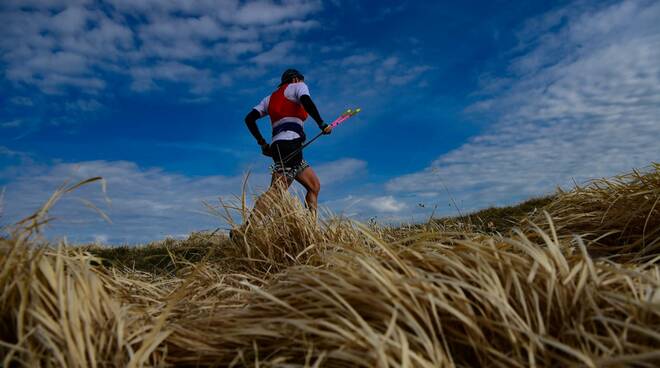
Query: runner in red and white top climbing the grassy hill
xmin=245 ymin=69 xmax=332 ymax=226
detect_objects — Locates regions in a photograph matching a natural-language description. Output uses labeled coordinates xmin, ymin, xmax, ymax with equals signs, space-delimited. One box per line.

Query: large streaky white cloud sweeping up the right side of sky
xmin=386 ymin=1 xmax=660 ymax=213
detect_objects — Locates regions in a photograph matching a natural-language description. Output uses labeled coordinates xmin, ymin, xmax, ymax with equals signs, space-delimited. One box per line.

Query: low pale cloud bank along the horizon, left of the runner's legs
xmin=0 ymin=156 xmax=366 ymax=243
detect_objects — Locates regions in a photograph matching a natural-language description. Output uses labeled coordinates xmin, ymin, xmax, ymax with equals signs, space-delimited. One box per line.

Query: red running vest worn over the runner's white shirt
xmin=268 ymin=84 xmax=307 ymax=139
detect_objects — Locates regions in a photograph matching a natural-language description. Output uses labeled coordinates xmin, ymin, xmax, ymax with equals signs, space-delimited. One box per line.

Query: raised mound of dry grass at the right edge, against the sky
xmin=530 ymin=163 xmax=660 ymax=262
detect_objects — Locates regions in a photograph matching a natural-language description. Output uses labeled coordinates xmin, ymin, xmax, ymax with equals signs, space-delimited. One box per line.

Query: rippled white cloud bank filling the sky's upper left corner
xmin=0 ymin=0 xmax=322 ymax=98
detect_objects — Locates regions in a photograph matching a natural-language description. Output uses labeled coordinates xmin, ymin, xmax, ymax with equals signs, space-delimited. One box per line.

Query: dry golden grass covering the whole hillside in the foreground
xmin=0 ymin=165 xmax=660 ymax=367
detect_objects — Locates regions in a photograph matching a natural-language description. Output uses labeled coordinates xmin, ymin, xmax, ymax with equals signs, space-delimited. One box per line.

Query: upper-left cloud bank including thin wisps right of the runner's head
xmin=0 ymin=0 xmax=429 ymax=135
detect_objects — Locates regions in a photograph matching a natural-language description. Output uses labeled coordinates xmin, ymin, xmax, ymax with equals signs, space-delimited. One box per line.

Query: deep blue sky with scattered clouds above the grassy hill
xmin=0 ymin=0 xmax=660 ymax=243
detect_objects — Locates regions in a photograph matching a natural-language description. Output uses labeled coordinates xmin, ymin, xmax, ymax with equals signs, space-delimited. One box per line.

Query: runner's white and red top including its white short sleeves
xmin=254 ymin=82 xmax=309 ymax=142
